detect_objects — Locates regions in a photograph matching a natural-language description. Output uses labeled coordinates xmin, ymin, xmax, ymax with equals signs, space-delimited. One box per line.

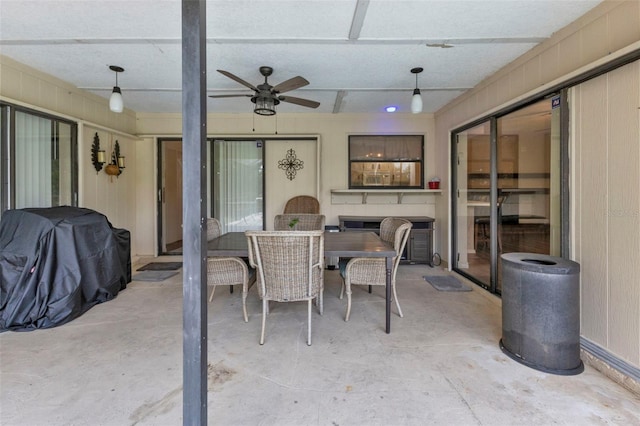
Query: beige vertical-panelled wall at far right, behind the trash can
xmin=571 ymin=61 xmax=640 ymax=365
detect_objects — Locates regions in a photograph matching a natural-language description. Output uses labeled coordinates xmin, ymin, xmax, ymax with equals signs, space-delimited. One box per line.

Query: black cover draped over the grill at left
xmin=0 ymin=206 xmax=131 ymax=331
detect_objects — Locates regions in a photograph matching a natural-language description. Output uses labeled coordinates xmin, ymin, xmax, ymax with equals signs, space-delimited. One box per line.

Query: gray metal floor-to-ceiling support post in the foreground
xmin=182 ymin=0 xmax=207 ymax=426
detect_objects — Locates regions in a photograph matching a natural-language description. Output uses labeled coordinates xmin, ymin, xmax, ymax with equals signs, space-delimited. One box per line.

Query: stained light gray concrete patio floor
xmin=0 ymin=259 xmax=640 ymax=426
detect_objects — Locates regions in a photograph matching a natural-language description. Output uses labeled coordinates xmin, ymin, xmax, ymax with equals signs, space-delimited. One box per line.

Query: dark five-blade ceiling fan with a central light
xmin=209 ymin=67 xmax=320 ymax=115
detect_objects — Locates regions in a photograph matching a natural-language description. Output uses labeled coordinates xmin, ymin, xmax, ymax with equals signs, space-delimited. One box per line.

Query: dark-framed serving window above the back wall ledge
xmin=349 ymin=135 xmax=424 ymax=189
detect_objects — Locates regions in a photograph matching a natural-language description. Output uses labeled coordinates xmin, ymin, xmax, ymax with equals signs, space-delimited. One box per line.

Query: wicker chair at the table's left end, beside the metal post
xmin=207 ymin=218 xmax=256 ymax=322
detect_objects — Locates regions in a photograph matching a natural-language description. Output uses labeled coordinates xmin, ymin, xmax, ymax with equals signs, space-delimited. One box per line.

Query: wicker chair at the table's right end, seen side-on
xmin=340 ymin=217 xmax=412 ymax=321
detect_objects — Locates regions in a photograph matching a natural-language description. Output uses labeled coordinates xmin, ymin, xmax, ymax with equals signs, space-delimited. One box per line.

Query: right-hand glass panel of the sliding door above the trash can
xmin=496 ymin=97 xmax=561 ymax=293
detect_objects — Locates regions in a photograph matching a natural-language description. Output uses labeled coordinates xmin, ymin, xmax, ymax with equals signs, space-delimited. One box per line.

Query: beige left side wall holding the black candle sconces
xmin=0 ymin=55 xmax=142 ymax=256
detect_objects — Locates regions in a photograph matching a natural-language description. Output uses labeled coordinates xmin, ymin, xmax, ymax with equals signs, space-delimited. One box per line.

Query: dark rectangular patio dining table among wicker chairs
xmin=207 ymin=232 xmax=396 ymax=334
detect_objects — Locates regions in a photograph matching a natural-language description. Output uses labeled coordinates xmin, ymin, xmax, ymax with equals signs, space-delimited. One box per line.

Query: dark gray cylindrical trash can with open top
xmin=500 ymin=253 xmax=584 ymax=375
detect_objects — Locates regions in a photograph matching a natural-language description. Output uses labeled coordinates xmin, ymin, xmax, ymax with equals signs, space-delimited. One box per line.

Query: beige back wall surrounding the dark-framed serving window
xmin=136 ymin=113 xmax=438 ymax=252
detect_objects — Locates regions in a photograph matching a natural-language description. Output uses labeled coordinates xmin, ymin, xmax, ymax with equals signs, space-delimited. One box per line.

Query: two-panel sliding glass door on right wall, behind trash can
xmin=452 ymin=96 xmax=561 ymax=293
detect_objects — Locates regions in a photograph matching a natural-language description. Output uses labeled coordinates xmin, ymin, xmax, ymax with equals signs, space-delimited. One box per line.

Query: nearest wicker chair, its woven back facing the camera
xmin=245 ymin=231 xmax=324 ymax=345
